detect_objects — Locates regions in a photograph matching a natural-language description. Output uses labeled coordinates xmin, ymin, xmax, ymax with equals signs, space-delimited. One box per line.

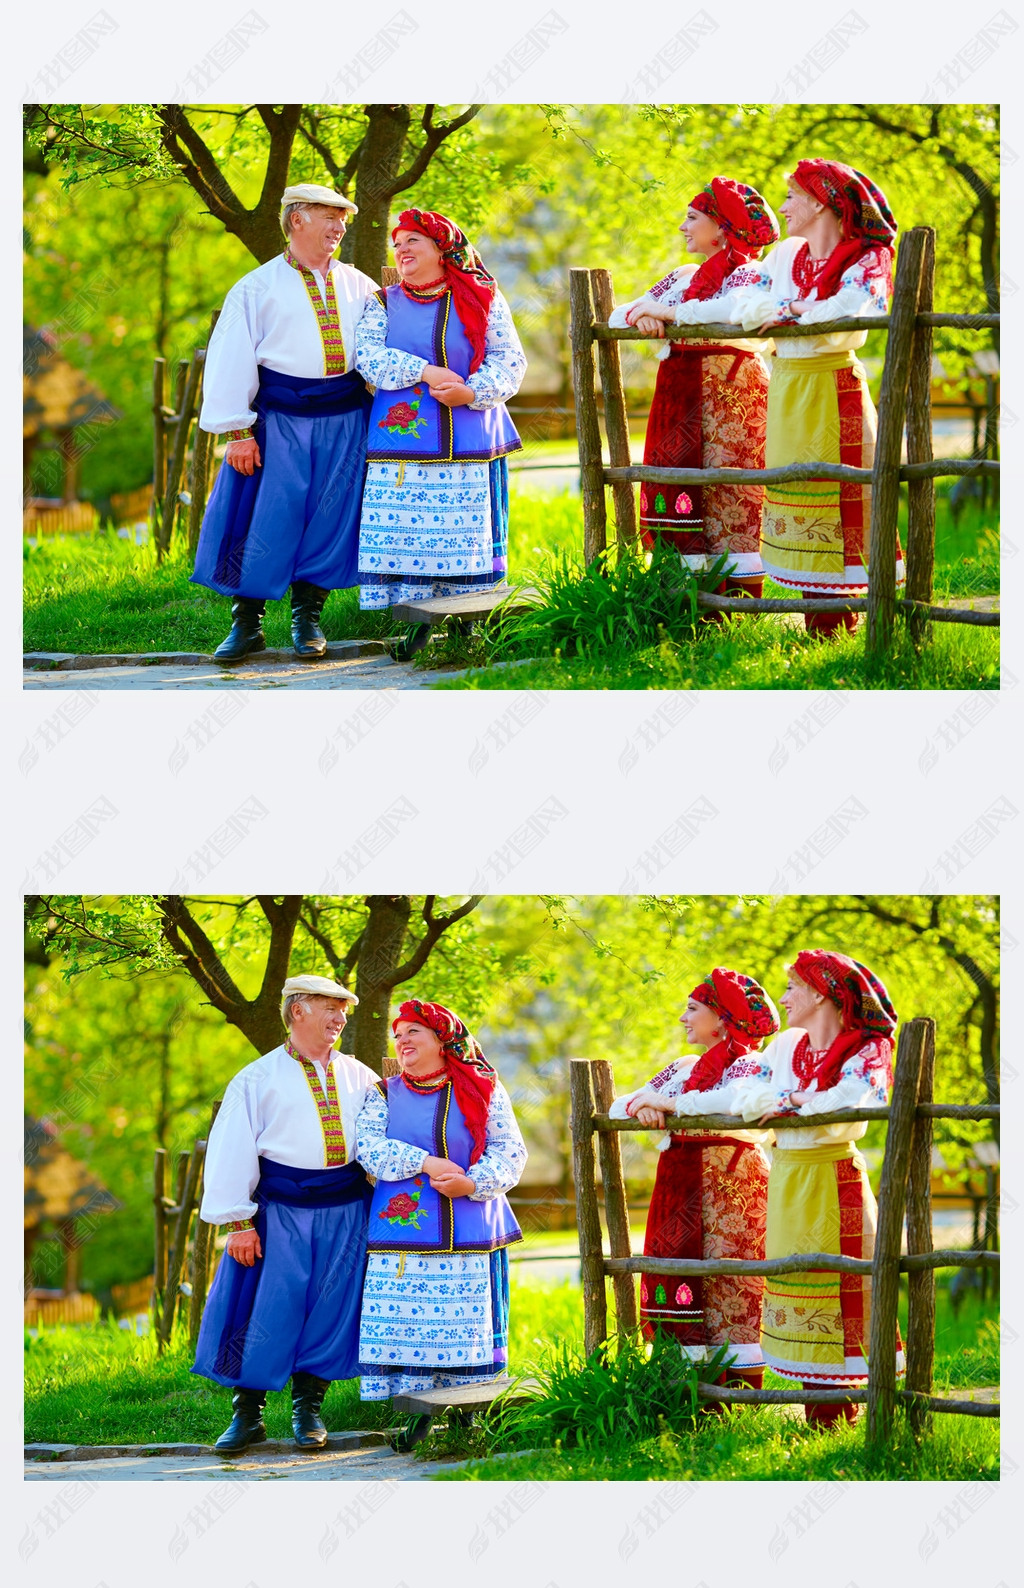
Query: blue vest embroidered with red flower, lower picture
xmin=367 ymin=1075 xmax=522 ymax=1251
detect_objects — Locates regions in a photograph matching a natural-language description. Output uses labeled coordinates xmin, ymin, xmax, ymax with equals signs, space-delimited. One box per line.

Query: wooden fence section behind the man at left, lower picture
xmin=152 ymin=1102 xmax=221 ymax=1351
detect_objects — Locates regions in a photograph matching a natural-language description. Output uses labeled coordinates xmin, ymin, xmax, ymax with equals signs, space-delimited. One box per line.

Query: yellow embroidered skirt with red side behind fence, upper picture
xmin=762 ymin=353 xmax=903 ymax=596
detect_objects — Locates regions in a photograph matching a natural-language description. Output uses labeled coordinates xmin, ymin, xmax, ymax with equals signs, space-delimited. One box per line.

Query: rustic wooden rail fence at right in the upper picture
xmin=568 ymin=225 xmax=999 ymax=653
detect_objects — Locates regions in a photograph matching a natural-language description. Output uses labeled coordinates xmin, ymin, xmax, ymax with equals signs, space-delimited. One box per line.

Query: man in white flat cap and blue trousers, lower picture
xmin=192 ymin=975 xmax=378 ymax=1455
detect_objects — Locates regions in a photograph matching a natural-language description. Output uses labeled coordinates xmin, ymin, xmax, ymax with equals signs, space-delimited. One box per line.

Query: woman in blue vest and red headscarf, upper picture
xmin=356 ymin=210 xmax=525 ymax=654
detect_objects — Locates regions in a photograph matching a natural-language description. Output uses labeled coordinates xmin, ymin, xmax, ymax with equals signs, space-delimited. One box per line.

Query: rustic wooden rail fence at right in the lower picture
xmin=570 ymin=1019 xmax=999 ymax=1442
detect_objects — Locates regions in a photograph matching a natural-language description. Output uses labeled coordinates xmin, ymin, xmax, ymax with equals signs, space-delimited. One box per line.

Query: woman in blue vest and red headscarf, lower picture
xmin=356 ymin=1000 xmax=525 ymax=1401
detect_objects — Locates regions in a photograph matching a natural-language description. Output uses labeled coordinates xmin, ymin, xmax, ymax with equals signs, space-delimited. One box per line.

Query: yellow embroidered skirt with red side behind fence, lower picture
xmin=760 ymin=1142 xmax=903 ymax=1386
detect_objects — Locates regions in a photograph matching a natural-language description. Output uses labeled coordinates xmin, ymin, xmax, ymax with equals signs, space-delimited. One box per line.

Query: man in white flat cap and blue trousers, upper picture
xmin=192 ymin=183 xmax=376 ymax=662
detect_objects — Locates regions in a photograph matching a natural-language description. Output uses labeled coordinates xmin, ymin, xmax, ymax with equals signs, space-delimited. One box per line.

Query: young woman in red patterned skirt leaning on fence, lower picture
xmin=611 ymin=967 xmax=780 ymax=1390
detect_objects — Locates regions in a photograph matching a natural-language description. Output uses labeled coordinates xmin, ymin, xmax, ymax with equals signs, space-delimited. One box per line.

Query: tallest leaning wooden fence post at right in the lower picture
xmin=867 ymin=1019 xmax=927 ymax=1443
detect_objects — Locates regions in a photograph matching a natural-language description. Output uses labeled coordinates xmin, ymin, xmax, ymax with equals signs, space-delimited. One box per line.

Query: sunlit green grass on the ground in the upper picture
xmin=24 ymin=476 xmax=999 ymax=689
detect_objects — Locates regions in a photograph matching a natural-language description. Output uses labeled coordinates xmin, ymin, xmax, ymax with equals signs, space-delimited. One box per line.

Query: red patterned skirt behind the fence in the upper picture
xmin=640 ymin=341 xmax=768 ymax=578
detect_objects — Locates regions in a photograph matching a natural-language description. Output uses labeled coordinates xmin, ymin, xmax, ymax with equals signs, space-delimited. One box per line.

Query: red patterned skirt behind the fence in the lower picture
xmin=640 ymin=1134 xmax=768 ymax=1367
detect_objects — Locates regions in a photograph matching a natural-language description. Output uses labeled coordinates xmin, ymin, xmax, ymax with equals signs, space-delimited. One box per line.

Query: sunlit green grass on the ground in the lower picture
xmin=25 ymin=1270 xmax=999 ymax=1482
